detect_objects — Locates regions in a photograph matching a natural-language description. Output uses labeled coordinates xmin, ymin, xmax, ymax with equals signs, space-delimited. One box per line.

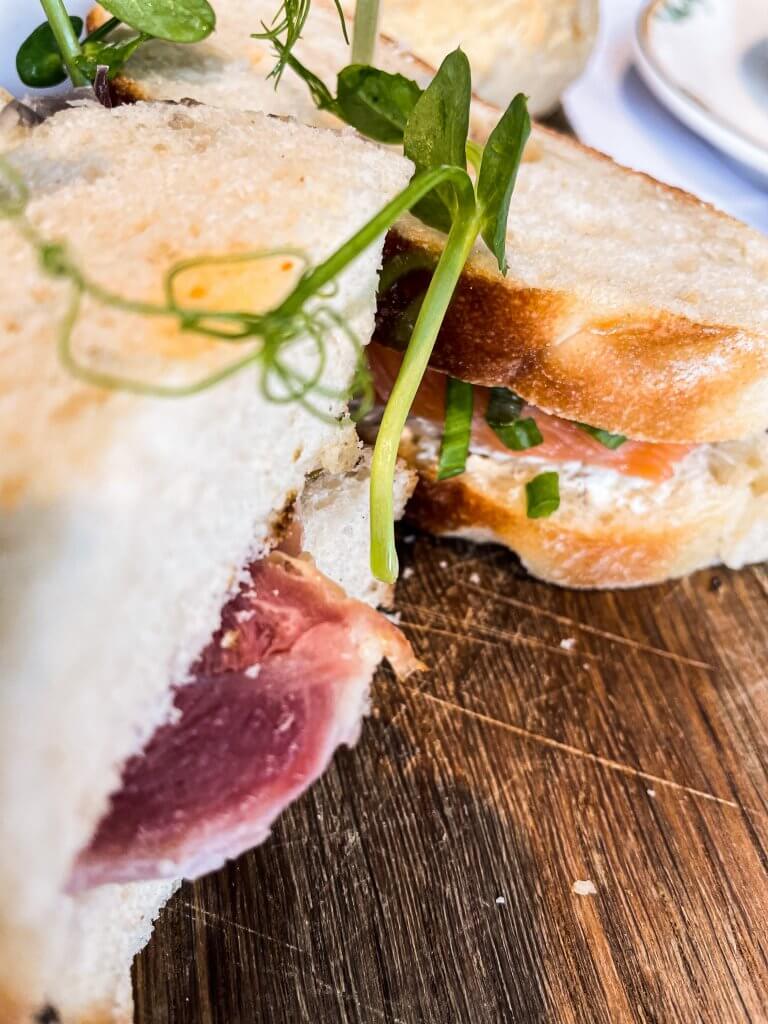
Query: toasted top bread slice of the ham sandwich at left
xmin=0 ymin=103 xmax=411 ymax=1022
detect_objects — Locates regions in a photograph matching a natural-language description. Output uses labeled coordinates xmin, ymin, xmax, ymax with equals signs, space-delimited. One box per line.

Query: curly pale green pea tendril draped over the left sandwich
xmin=0 ymin=159 xmax=468 ymax=428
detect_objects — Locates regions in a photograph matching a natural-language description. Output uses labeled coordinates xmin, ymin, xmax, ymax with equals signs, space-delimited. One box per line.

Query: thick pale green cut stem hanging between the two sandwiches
xmin=371 ymin=203 xmax=480 ymax=583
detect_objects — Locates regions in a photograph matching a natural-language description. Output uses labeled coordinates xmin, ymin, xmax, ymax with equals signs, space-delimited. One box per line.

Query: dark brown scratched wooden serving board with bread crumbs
xmin=135 ymin=527 xmax=768 ymax=1024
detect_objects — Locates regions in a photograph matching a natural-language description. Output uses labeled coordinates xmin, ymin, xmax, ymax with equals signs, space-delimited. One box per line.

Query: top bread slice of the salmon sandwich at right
xmin=93 ymin=0 xmax=768 ymax=442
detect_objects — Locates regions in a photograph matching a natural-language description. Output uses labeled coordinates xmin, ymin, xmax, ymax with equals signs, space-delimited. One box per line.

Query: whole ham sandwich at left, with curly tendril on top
xmin=0 ymin=100 xmax=414 ymax=1024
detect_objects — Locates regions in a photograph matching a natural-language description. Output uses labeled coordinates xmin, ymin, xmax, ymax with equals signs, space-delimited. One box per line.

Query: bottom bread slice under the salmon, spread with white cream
xmin=401 ymin=428 xmax=768 ymax=588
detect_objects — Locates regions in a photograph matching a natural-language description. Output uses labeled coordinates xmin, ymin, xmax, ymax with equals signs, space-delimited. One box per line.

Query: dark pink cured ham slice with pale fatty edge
xmin=70 ymin=554 xmax=418 ymax=891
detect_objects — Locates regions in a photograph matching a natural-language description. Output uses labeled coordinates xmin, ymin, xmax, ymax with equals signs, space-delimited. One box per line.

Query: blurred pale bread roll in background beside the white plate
xmin=381 ymin=0 xmax=598 ymax=117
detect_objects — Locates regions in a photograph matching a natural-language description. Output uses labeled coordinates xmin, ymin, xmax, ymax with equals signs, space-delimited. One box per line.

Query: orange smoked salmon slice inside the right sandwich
xmin=367 ymin=343 xmax=692 ymax=480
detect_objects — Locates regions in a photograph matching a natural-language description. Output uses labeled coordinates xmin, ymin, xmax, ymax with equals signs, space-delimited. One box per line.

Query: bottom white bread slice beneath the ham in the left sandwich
xmin=31 ymin=452 xmax=416 ymax=1024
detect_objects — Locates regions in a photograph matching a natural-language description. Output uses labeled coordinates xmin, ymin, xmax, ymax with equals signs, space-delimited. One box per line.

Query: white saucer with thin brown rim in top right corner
xmin=635 ymin=0 xmax=768 ymax=186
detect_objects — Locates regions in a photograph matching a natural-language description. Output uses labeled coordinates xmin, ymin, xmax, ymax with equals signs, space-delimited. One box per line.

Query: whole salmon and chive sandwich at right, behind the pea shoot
xmin=99 ymin=0 xmax=768 ymax=587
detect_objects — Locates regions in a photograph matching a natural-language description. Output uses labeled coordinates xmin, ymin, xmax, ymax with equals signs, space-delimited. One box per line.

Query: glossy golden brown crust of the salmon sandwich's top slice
xmin=376 ymin=230 xmax=768 ymax=442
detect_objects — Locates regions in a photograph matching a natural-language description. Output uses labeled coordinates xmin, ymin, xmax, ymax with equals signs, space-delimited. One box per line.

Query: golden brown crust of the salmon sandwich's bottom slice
xmin=408 ymin=468 xmax=711 ymax=589
